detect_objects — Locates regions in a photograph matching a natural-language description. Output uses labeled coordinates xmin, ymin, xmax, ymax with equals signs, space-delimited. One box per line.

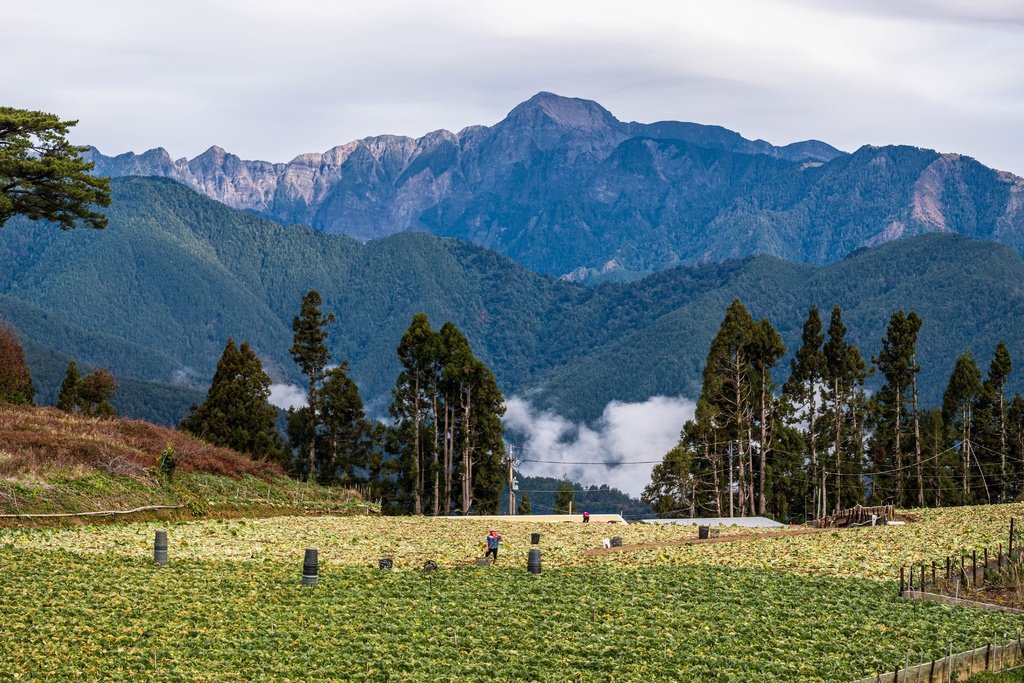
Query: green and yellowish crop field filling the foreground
xmin=0 ymin=505 xmax=1024 ymax=681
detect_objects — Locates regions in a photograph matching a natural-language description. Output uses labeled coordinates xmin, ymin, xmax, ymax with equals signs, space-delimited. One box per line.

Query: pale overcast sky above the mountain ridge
xmin=8 ymin=0 xmax=1024 ymax=175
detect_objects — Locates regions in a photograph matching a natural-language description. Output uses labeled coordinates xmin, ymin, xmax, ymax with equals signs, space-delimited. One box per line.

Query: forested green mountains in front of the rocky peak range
xmin=0 ymin=180 xmax=1024 ymax=422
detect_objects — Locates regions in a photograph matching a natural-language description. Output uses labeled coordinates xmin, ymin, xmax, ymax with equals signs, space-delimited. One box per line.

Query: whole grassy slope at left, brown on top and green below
xmin=0 ymin=404 xmax=372 ymax=524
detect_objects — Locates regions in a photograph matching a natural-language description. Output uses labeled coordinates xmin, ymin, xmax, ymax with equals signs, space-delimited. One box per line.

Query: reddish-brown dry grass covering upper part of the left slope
xmin=0 ymin=403 xmax=283 ymax=481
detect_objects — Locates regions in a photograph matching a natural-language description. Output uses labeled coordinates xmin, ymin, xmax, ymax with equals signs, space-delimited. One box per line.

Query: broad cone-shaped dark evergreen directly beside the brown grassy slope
xmin=181 ymin=338 xmax=284 ymax=460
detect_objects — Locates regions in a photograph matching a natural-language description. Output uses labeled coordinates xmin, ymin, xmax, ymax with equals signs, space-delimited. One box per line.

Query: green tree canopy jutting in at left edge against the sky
xmin=0 ymin=106 xmax=111 ymax=229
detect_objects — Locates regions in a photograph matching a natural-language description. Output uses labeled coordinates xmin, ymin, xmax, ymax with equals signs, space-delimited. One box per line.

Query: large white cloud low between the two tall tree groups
xmin=503 ymin=396 xmax=695 ymax=496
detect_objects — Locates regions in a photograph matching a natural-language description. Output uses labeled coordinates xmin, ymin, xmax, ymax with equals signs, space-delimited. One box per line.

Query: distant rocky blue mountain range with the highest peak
xmin=87 ymin=92 xmax=1024 ymax=280
